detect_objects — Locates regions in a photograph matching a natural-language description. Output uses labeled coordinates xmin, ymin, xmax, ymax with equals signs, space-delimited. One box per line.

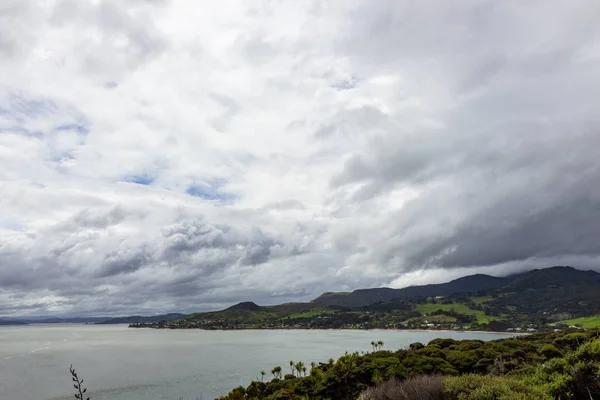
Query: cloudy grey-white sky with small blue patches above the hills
xmin=0 ymin=0 xmax=600 ymax=316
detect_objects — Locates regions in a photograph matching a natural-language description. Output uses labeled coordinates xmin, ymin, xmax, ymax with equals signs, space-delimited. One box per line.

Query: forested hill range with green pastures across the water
xmin=132 ymin=267 xmax=600 ymax=331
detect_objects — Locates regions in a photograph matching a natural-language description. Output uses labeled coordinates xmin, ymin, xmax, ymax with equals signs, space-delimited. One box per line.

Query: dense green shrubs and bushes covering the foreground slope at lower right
xmin=220 ymin=330 xmax=600 ymax=400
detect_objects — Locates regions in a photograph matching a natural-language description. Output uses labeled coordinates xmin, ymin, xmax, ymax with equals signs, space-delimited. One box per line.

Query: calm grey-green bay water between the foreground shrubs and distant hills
xmin=0 ymin=325 xmax=506 ymax=400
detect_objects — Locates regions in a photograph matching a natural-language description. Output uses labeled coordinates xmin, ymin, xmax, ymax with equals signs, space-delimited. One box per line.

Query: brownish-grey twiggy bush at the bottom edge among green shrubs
xmin=360 ymin=375 xmax=444 ymax=400
